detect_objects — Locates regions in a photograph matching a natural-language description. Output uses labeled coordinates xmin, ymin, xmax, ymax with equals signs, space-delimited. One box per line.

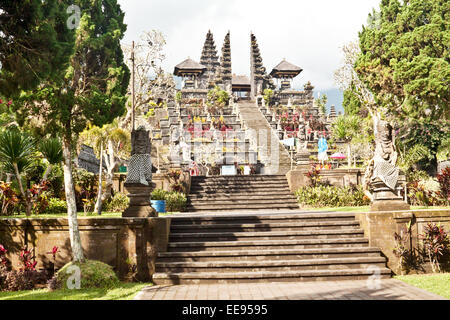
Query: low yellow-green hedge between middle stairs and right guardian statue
xmin=295 ymin=185 xmax=370 ymax=207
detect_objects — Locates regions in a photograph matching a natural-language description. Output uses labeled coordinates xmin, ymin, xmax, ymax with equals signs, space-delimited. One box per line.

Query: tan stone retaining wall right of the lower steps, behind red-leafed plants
xmin=356 ymin=209 xmax=450 ymax=274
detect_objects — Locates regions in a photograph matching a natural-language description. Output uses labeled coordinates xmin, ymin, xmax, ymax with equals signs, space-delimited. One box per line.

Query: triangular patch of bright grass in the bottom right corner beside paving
xmin=394 ymin=273 xmax=450 ymax=299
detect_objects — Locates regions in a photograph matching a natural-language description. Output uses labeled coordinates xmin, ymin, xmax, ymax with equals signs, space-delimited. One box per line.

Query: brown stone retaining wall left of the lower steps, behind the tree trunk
xmin=0 ymin=218 xmax=170 ymax=281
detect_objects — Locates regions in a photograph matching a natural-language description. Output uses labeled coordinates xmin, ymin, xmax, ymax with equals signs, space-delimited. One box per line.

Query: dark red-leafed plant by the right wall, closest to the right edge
xmin=420 ymin=223 xmax=450 ymax=272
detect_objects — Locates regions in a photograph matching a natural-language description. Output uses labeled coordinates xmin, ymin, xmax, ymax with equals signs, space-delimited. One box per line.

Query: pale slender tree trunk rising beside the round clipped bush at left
xmin=63 ymin=137 xmax=84 ymax=262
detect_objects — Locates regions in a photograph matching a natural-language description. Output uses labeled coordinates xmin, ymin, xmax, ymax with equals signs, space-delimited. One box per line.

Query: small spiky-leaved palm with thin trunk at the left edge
xmin=0 ymin=128 xmax=36 ymax=216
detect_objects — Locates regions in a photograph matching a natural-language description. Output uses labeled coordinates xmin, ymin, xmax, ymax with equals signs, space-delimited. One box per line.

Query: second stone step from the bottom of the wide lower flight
xmin=155 ymin=256 xmax=386 ymax=272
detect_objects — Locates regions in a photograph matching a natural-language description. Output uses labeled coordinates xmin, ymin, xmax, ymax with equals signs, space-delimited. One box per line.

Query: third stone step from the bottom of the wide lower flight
xmin=158 ymin=247 xmax=380 ymax=262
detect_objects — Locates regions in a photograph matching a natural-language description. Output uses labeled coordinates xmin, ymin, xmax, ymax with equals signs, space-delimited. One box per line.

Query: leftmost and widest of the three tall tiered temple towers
xmin=200 ymin=30 xmax=220 ymax=88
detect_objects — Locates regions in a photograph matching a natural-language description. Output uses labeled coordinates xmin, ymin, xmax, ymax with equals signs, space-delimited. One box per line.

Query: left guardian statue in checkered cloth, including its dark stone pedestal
xmin=122 ymin=126 xmax=157 ymax=217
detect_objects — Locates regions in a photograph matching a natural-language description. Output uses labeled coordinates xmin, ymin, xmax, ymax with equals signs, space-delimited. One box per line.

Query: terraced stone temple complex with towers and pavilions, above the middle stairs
xmin=154 ymin=31 xmax=335 ymax=174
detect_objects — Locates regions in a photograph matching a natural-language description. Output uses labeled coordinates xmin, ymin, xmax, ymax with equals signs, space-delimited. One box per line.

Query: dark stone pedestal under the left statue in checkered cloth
xmin=122 ymin=183 xmax=158 ymax=218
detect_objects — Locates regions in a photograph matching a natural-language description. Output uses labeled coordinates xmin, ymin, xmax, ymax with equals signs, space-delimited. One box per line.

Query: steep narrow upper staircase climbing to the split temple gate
xmin=238 ymin=101 xmax=291 ymax=174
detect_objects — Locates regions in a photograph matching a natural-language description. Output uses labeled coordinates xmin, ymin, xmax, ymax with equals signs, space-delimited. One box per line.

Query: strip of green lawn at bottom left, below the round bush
xmin=0 ymin=283 xmax=151 ymax=300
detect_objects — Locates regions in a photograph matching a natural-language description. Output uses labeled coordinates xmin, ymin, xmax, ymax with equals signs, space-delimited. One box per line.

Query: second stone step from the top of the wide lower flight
xmin=170 ymin=220 xmax=359 ymax=234
